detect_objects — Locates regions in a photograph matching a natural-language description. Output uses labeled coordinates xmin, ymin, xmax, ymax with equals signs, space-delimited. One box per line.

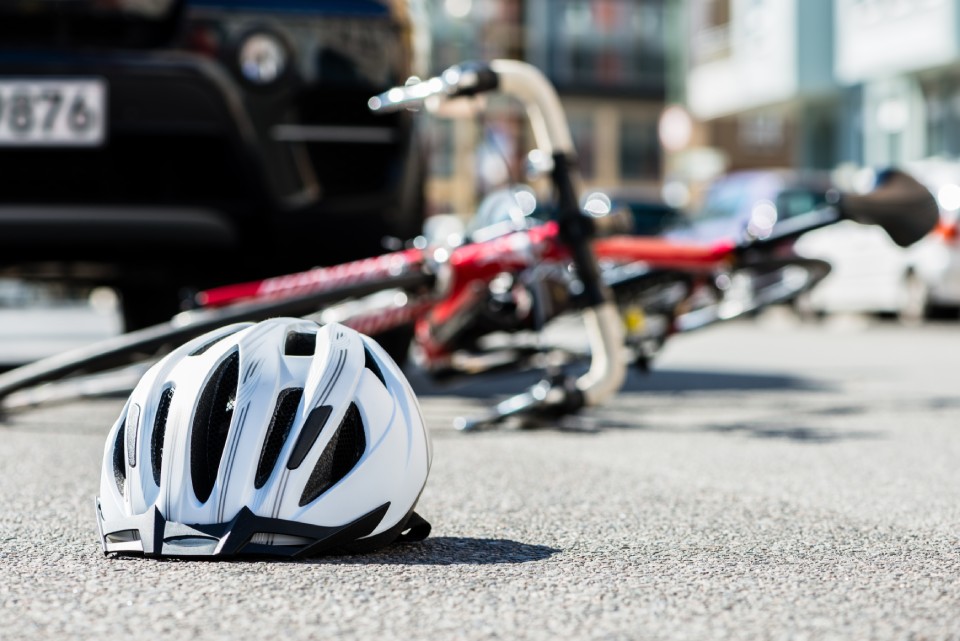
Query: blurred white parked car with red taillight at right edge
xmin=794 ymin=165 xmax=960 ymax=322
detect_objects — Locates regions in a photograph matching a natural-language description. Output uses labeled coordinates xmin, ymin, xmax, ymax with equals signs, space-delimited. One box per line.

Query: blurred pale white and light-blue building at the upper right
xmin=680 ymin=0 xmax=960 ymax=175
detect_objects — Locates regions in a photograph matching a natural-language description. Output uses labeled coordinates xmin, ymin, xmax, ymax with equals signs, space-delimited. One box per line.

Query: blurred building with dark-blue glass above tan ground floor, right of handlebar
xmin=525 ymin=0 xmax=666 ymax=186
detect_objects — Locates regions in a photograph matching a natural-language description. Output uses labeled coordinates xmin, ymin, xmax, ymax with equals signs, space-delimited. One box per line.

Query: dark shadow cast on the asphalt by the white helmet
xmin=308 ymin=536 xmax=561 ymax=565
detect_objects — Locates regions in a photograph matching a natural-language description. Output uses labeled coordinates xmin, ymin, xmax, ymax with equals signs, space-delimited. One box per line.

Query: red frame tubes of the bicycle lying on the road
xmin=197 ymin=222 xmax=734 ymax=348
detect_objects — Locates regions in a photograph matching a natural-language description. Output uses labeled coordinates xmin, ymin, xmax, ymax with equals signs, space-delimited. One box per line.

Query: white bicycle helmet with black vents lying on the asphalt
xmin=97 ymin=318 xmax=432 ymax=557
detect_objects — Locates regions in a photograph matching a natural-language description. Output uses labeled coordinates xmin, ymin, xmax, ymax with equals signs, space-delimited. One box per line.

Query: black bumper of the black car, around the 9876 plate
xmin=0 ymin=51 xmax=414 ymax=280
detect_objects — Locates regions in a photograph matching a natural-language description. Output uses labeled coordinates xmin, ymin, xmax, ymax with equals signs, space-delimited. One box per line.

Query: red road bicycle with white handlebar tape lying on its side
xmin=0 ymin=61 xmax=938 ymax=421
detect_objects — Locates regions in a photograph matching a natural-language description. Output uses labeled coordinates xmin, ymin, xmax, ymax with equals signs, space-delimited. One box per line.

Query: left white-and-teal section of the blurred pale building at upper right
xmin=684 ymin=0 xmax=843 ymax=169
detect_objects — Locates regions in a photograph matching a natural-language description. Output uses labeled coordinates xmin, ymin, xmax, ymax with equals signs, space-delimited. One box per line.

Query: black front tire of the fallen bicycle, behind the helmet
xmin=0 ymin=272 xmax=434 ymax=401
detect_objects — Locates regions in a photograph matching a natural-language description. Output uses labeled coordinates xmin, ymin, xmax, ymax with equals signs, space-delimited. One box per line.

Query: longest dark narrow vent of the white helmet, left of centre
xmin=190 ymin=351 xmax=240 ymax=503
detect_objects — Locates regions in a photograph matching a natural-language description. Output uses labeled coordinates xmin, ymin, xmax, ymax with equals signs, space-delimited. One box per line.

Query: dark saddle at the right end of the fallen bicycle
xmin=837 ymin=169 xmax=940 ymax=247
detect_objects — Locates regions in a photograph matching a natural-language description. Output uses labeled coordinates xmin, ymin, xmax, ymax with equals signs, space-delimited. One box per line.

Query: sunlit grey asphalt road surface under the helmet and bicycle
xmin=0 ymin=319 xmax=960 ymax=641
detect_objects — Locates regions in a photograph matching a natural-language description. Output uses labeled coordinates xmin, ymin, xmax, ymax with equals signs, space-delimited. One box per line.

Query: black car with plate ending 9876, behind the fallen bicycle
xmin=0 ymin=0 xmax=429 ymax=329
